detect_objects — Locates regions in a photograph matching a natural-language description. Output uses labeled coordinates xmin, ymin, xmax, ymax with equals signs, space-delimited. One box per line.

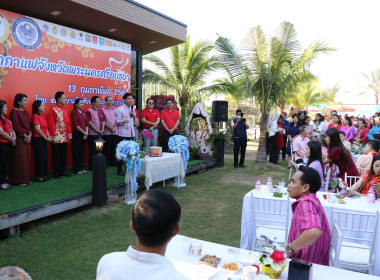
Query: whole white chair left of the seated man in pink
xmin=251 ymin=193 xmax=289 ymax=251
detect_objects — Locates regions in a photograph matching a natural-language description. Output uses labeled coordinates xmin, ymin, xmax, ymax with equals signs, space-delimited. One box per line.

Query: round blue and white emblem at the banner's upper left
xmin=12 ymin=17 xmax=42 ymax=50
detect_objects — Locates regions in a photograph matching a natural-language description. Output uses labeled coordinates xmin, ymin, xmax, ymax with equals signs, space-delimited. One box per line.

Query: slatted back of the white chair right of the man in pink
xmin=330 ymin=207 xmax=379 ymax=264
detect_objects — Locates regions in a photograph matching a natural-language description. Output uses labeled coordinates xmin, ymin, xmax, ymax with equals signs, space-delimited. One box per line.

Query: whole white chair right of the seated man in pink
xmin=330 ymin=208 xmax=379 ymax=275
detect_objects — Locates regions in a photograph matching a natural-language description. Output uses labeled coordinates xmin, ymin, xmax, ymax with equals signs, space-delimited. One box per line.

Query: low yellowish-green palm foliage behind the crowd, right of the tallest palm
xmin=289 ymin=82 xmax=339 ymax=110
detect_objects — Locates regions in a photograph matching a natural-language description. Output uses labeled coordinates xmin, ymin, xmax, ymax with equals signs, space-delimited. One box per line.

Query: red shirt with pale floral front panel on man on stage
xmin=48 ymin=105 xmax=72 ymax=143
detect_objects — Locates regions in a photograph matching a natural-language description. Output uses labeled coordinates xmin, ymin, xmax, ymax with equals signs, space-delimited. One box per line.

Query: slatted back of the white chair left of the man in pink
xmin=251 ymin=193 xmax=289 ymax=246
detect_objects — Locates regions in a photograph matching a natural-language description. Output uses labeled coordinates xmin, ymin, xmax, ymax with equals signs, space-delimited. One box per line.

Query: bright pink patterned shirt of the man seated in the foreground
xmin=288 ymin=193 xmax=331 ymax=265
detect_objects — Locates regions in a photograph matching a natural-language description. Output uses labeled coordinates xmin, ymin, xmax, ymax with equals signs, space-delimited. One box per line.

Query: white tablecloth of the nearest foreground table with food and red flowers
xmin=165 ymin=235 xmax=379 ymax=280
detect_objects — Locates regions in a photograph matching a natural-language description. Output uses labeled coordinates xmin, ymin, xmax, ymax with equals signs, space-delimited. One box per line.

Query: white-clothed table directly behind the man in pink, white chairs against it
xmin=240 ymin=190 xmax=380 ymax=279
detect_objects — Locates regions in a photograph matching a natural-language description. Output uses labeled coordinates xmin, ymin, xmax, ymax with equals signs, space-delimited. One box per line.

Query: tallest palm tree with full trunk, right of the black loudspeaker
xmin=216 ymin=22 xmax=332 ymax=162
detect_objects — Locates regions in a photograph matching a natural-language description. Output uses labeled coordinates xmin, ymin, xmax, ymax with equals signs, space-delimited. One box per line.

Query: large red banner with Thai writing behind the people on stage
xmin=0 ymin=9 xmax=131 ymax=170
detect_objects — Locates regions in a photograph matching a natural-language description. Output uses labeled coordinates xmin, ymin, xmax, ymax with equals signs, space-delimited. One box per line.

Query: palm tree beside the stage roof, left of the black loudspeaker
xmin=143 ymin=36 xmax=219 ymax=120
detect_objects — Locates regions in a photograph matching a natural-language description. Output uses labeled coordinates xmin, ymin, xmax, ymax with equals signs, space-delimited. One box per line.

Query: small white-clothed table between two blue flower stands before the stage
xmin=138 ymin=153 xmax=185 ymax=190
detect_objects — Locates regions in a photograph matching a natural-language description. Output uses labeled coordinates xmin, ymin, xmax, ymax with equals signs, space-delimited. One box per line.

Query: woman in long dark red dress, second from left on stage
xmin=10 ymin=93 xmax=32 ymax=186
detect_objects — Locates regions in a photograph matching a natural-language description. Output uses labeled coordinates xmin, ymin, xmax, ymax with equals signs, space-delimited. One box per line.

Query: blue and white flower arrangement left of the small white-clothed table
xmin=116 ymin=140 xmax=141 ymax=190
